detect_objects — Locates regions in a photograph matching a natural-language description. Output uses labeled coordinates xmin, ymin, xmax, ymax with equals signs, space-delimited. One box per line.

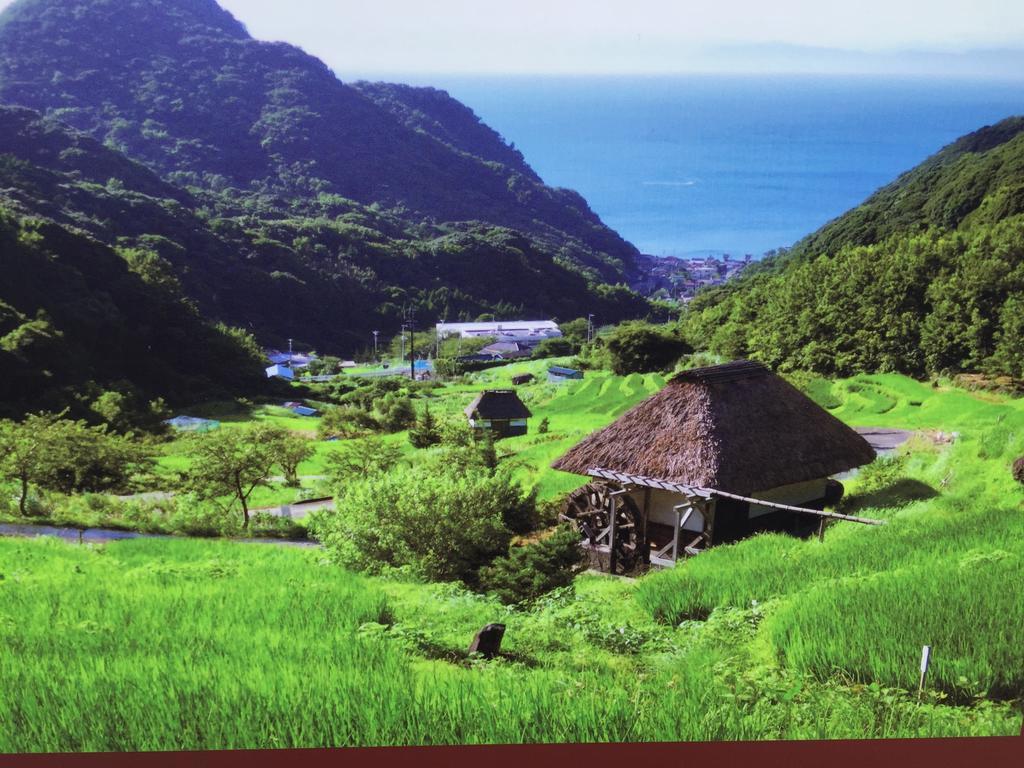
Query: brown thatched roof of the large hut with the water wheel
xmin=552 ymin=360 xmax=874 ymax=494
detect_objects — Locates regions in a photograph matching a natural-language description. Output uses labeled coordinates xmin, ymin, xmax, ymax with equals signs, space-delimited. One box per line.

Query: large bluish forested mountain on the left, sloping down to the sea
xmin=0 ymin=0 xmax=648 ymax=360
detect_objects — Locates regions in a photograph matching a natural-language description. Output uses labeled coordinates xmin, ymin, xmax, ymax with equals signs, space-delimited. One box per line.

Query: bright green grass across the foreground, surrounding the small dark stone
xmin=0 ymin=540 xmax=1020 ymax=752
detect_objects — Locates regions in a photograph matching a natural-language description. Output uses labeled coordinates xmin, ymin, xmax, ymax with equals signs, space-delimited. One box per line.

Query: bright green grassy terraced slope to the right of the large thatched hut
xmin=637 ymin=377 xmax=1024 ymax=716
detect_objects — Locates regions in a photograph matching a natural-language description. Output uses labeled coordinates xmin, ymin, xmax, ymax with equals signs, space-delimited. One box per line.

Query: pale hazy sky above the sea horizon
xmin=0 ymin=0 xmax=1024 ymax=76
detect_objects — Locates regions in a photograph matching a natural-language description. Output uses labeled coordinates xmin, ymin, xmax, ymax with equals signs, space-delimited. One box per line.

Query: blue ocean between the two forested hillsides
xmin=395 ymin=76 xmax=1024 ymax=256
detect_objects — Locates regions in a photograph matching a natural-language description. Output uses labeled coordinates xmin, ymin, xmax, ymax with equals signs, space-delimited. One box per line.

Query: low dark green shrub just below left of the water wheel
xmin=480 ymin=526 xmax=586 ymax=604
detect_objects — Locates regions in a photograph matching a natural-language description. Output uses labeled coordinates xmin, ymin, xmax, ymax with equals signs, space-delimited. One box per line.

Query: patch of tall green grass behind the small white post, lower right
xmin=768 ymin=550 xmax=1024 ymax=700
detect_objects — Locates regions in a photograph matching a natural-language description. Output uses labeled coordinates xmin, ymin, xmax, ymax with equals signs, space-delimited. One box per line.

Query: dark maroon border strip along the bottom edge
xmin=0 ymin=735 xmax=1024 ymax=768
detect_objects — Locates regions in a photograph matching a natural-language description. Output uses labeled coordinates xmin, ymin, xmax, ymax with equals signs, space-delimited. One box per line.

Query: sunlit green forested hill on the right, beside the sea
xmin=683 ymin=118 xmax=1024 ymax=376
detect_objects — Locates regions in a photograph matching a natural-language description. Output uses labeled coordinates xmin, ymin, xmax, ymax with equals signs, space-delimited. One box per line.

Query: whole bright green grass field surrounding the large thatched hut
xmin=0 ymin=372 xmax=1024 ymax=752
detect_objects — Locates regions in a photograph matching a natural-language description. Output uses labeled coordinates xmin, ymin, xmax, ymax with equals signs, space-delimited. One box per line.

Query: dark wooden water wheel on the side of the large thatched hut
xmin=562 ymin=482 xmax=640 ymax=573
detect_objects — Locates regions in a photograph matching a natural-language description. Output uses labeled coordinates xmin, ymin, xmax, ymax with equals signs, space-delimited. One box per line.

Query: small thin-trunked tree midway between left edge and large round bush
xmin=185 ymin=425 xmax=281 ymax=529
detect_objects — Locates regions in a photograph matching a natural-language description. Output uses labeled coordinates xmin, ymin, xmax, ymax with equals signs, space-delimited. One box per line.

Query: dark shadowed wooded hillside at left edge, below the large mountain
xmin=0 ymin=196 xmax=266 ymax=423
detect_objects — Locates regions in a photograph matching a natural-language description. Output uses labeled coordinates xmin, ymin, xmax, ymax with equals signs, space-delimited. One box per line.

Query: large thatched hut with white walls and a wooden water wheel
xmin=553 ymin=360 xmax=876 ymax=570
